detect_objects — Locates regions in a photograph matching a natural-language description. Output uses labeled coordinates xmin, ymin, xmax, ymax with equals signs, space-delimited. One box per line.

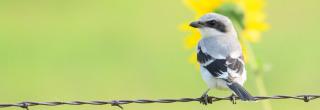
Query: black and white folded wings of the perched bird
xmin=197 ymin=46 xmax=244 ymax=81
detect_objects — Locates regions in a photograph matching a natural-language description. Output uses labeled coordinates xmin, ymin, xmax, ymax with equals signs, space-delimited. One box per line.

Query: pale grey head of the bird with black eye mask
xmin=190 ymin=13 xmax=236 ymax=37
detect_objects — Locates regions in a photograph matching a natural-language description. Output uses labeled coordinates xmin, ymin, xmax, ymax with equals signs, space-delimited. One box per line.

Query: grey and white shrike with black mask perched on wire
xmin=190 ymin=13 xmax=255 ymax=105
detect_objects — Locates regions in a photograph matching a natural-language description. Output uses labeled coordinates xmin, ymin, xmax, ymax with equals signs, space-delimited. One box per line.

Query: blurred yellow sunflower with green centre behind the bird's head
xmin=181 ymin=0 xmax=269 ymax=63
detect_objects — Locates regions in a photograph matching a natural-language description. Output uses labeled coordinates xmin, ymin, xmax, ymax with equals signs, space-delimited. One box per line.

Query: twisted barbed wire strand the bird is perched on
xmin=0 ymin=95 xmax=320 ymax=110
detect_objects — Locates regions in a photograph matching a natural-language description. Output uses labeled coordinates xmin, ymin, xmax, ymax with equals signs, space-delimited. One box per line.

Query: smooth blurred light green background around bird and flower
xmin=0 ymin=0 xmax=320 ymax=110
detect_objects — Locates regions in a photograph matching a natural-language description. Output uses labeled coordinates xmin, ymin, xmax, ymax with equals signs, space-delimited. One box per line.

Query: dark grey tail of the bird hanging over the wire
xmin=227 ymin=82 xmax=255 ymax=101
